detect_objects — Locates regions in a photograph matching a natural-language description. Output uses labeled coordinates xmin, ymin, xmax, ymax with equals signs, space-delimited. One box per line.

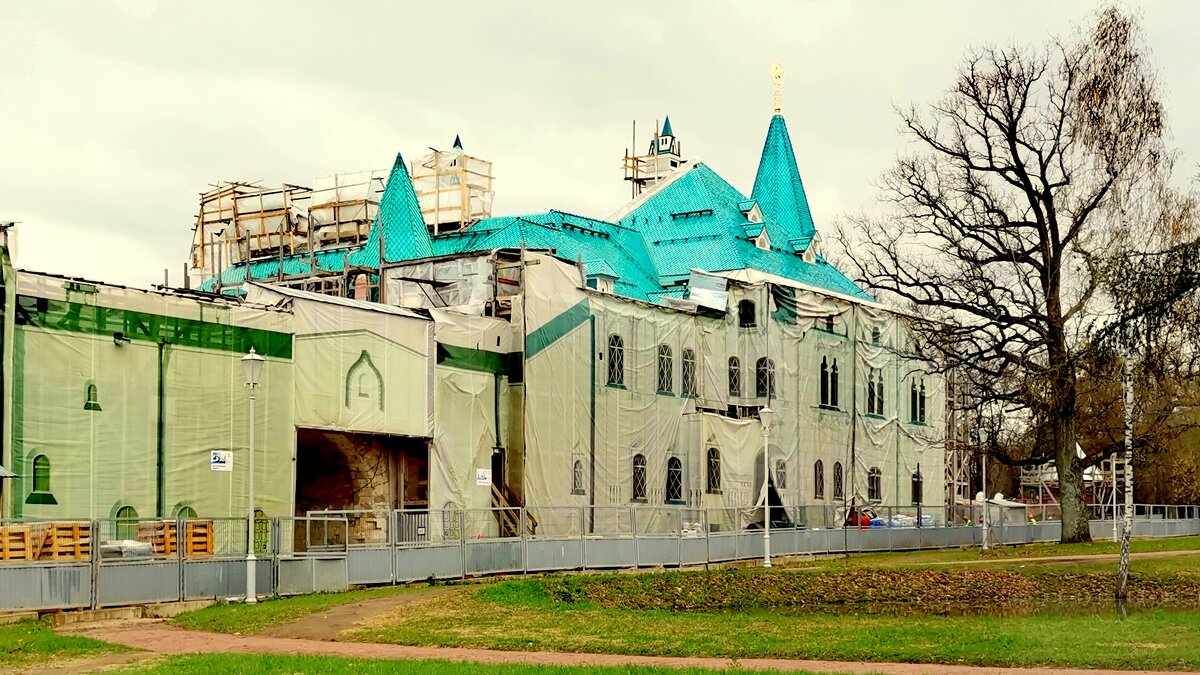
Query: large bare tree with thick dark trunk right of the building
xmin=840 ymin=7 xmax=1170 ymax=542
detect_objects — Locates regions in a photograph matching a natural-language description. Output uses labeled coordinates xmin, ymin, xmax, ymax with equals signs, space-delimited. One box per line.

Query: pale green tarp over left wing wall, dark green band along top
xmin=11 ymin=273 xmax=294 ymax=518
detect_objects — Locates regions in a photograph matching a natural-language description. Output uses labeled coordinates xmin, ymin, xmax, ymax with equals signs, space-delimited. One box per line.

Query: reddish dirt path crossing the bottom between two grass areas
xmin=60 ymin=620 xmax=1195 ymax=675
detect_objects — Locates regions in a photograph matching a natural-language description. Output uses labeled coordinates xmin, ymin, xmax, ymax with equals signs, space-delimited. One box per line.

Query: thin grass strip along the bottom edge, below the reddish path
xmin=121 ymin=653 xmax=835 ymax=675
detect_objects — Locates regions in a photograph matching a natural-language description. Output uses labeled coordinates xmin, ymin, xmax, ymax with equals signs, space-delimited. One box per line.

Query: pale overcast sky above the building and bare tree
xmin=0 ymin=0 xmax=1200 ymax=286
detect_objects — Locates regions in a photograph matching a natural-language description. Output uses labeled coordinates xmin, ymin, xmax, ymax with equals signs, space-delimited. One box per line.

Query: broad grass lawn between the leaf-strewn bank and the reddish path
xmin=353 ymin=572 xmax=1200 ymax=670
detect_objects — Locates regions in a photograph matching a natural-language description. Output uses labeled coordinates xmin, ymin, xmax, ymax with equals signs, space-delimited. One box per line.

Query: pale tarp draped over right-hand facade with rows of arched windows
xmin=524 ymin=253 xmax=944 ymax=532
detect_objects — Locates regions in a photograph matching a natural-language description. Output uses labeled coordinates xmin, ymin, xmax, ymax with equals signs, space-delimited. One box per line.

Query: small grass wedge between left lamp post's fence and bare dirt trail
xmin=172 ymin=586 xmax=425 ymax=635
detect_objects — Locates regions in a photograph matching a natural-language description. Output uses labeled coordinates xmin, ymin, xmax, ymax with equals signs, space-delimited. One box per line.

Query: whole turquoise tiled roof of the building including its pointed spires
xmin=201 ymin=115 xmax=870 ymax=301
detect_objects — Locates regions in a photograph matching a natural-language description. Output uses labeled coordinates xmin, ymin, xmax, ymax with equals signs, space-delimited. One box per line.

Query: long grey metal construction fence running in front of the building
xmin=0 ymin=504 xmax=1200 ymax=611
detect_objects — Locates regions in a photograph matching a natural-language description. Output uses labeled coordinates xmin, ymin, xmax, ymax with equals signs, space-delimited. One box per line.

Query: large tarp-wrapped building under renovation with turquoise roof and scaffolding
xmin=0 ymin=82 xmax=947 ymax=540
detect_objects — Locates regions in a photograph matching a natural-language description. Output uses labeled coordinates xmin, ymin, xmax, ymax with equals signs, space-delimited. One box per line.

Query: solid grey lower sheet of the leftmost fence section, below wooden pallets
xmin=0 ymin=562 xmax=91 ymax=611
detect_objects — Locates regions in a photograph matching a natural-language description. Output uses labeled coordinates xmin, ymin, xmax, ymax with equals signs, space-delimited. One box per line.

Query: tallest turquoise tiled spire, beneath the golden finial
xmin=750 ymin=115 xmax=817 ymax=239
